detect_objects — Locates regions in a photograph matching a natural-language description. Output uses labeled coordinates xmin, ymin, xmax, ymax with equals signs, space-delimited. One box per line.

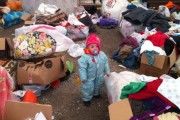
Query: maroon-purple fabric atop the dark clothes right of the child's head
xmin=120 ymin=36 xmax=139 ymax=48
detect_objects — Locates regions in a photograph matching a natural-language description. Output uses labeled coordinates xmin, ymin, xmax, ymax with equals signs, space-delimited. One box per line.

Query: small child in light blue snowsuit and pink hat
xmin=78 ymin=34 xmax=110 ymax=106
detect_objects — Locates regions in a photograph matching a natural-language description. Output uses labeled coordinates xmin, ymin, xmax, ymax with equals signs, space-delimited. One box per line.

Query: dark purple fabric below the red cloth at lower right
xmin=130 ymin=97 xmax=171 ymax=120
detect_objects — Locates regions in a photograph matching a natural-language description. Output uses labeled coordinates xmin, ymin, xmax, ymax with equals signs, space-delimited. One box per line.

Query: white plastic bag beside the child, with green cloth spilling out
xmin=105 ymin=71 xmax=157 ymax=104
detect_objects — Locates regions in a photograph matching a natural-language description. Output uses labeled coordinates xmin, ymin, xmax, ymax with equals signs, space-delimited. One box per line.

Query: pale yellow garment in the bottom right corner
xmin=158 ymin=112 xmax=179 ymax=120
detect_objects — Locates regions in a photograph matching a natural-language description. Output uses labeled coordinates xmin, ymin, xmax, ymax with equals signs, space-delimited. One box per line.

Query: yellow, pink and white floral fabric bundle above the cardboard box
xmin=13 ymin=31 xmax=56 ymax=59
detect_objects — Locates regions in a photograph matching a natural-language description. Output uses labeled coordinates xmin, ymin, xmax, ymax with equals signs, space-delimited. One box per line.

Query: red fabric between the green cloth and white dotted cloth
xmin=129 ymin=79 xmax=175 ymax=107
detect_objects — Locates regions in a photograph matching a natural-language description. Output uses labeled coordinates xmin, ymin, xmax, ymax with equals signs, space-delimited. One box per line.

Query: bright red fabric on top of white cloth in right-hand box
xmin=147 ymin=32 xmax=169 ymax=47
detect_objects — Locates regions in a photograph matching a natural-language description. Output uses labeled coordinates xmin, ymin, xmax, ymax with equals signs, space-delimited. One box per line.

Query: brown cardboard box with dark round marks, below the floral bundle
xmin=17 ymin=56 xmax=66 ymax=85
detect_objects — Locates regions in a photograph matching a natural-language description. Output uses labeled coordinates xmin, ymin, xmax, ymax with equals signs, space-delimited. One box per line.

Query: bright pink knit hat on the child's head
xmin=86 ymin=33 xmax=101 ymax=50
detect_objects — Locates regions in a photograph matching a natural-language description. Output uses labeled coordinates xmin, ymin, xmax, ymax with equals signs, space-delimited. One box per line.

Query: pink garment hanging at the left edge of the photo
xmin=0 ymin=67 xmax=13 ymax=120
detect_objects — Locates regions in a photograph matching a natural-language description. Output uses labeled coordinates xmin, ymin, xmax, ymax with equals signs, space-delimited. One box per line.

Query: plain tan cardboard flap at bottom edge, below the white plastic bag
xmin=109 ymin=99 xmax=133 ymax=120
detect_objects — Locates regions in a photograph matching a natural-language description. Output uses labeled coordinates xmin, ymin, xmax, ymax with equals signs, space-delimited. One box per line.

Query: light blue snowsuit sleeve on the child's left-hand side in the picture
xmin=78 ymin=56 xmax=87 ymax=81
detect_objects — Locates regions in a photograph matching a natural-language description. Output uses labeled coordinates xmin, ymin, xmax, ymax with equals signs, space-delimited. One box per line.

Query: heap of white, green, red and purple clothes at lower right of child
xmin=105 ymin=71 xmax=180 ymax=120
